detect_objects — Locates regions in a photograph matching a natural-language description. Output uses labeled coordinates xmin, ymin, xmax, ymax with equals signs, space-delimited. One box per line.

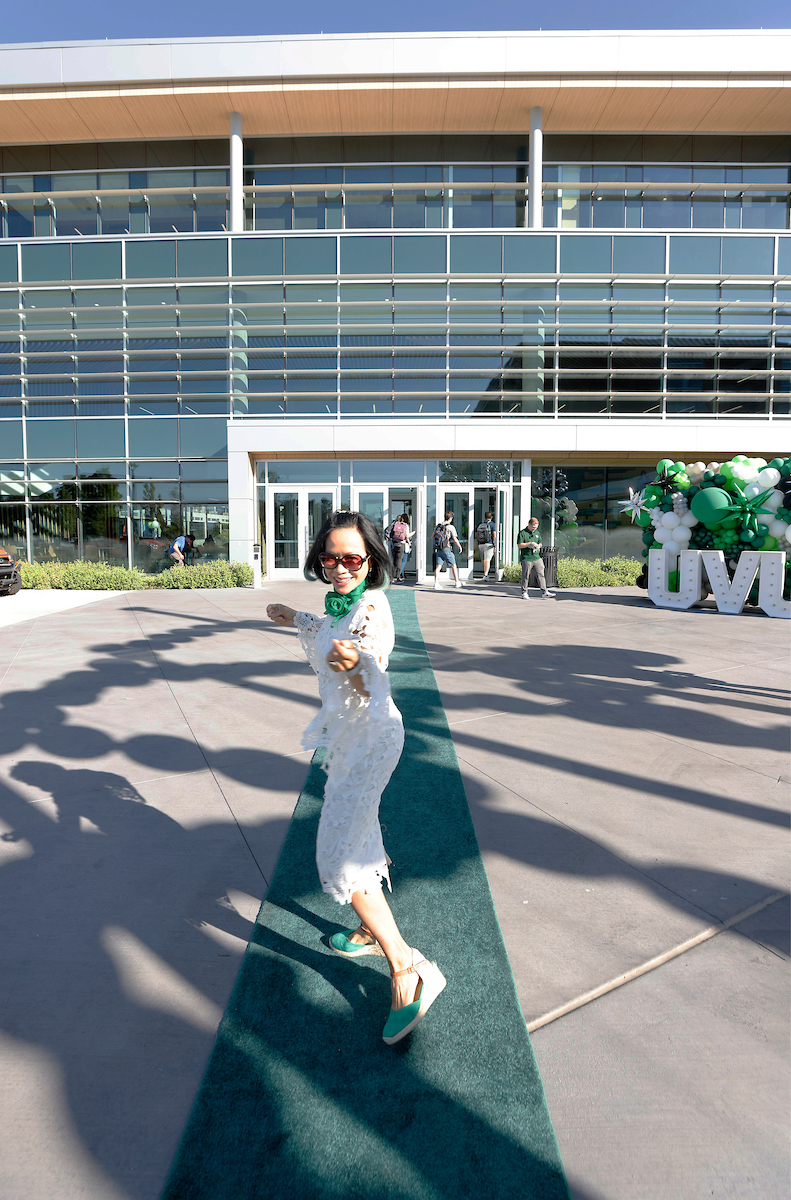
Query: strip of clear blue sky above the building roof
xmin=0 ymin=0 xmax=791 ymax=42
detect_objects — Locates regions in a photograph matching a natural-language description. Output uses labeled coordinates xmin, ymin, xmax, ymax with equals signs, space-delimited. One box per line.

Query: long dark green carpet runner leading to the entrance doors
xmin=163 ymin=592 xmax=569 ymax=1200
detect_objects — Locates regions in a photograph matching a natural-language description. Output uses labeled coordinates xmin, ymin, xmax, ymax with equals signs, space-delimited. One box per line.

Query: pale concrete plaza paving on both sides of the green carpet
xmin=0 ymin=583 xmax=790 ymax=1200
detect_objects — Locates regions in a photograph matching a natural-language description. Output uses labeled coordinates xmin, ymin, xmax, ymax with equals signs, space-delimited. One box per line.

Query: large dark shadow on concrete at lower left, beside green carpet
xmin=0 ymin=760 xmax=283 ymax=1200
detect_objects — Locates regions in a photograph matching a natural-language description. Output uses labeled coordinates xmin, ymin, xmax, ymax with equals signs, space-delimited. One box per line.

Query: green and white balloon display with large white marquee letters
xmin=622 ymin=455 xmax=791 ymax=618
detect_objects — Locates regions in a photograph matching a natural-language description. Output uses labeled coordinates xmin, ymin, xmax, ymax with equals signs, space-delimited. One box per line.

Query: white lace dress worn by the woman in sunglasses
xmin=294 ymin=590 xmax=403 ymax=904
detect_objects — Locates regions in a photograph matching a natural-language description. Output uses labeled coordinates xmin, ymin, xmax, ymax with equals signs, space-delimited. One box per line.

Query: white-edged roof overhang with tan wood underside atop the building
xmin=0 ymin=30 xmax=791 ymax=144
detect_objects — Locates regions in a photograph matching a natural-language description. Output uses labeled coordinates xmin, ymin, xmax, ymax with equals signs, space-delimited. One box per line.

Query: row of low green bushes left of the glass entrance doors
xmin=20 ymin=560 xmax=253 ymax=592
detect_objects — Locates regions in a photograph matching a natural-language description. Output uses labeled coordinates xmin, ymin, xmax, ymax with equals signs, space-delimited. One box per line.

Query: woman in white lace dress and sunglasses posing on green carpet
xmin=266 ymin=512 xmax=445 ymax=1044
